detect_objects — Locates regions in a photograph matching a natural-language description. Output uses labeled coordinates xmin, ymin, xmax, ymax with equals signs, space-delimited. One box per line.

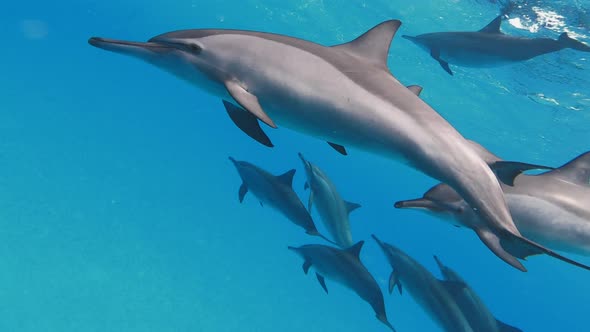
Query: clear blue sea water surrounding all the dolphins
xmin=0 ymin=0 xmax=590 ymax=332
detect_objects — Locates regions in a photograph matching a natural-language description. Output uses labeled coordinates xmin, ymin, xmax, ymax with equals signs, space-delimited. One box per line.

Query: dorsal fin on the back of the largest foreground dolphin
xmin=333 ymin=20 xmax=402 ymax=68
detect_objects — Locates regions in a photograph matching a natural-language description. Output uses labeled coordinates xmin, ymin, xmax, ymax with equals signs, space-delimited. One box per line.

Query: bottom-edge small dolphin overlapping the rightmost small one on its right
xmin=371 ymin=235 xmax=479 ymax=332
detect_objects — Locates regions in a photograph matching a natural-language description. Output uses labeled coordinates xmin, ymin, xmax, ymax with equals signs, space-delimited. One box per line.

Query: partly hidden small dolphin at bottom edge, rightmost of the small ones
xmin=434 ymin=256 xmax=522 ymax=332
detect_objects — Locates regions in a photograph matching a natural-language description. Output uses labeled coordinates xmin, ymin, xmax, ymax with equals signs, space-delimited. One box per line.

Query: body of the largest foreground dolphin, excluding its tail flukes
xmin=89 ymin=20 xmax=520 ymax=260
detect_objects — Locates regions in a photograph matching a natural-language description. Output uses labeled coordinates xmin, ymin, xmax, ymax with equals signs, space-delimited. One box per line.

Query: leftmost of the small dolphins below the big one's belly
xmin=229 ymin=157 xmax=323 ymax=238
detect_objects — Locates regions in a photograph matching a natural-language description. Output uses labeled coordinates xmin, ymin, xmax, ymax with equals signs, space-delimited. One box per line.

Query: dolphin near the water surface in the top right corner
xmin=402 ymin=15 xmax=590 ymax=75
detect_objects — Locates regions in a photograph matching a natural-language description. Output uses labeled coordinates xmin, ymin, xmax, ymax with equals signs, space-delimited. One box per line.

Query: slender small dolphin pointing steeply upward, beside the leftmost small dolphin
xmin=299 ymin=153 xmax=361 ymax=248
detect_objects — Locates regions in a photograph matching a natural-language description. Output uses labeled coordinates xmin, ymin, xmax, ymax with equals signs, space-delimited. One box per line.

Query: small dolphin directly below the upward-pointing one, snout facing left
xmin=289 ymin=241 xmax=395 ymax=331
